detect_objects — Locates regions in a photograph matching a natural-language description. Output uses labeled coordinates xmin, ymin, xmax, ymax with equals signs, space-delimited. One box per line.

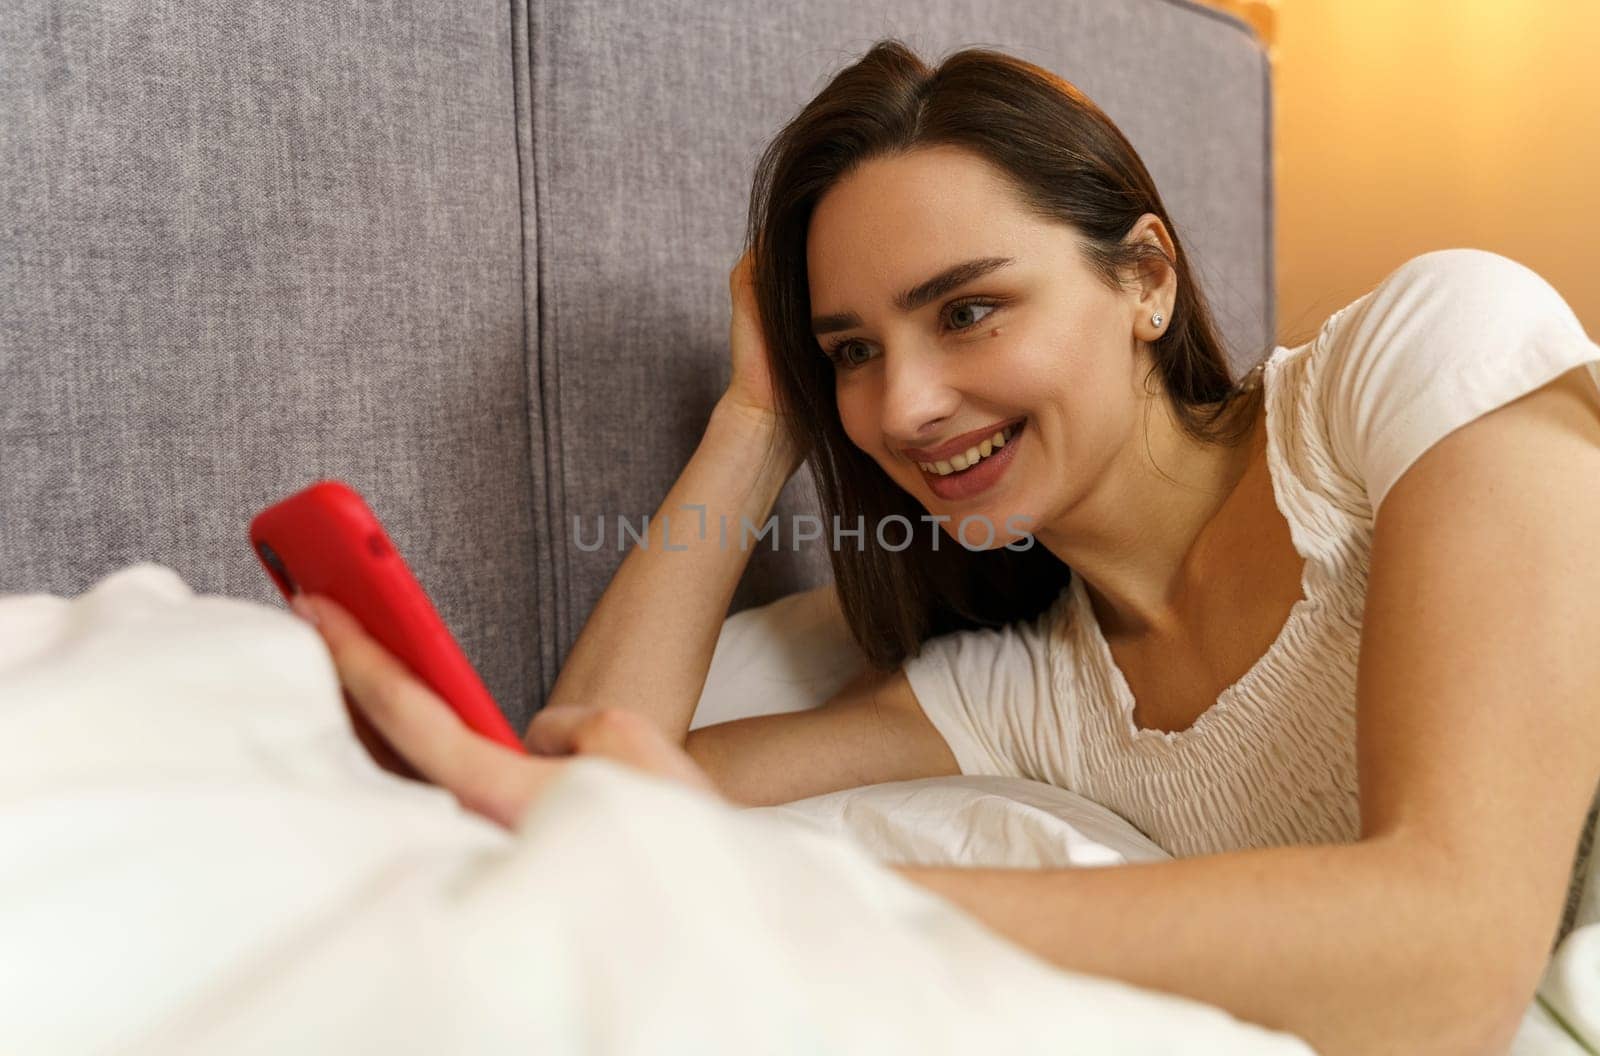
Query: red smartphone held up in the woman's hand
xmin=250 ymin=480 xmax=526 ymax=754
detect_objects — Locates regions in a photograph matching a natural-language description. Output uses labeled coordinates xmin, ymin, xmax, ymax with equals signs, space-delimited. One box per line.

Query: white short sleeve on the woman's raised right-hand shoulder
xmin=1317 ymin=250 xmax=1600 ymax=515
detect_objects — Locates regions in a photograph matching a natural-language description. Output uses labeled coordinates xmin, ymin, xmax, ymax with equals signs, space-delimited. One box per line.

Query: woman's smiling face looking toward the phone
xmin=806 ymin=147 xmax=1149 ymax=549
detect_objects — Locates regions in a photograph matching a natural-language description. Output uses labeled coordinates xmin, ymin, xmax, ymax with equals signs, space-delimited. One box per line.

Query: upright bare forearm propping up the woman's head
xmin=546 ymin=398 xmax=800 ymax=744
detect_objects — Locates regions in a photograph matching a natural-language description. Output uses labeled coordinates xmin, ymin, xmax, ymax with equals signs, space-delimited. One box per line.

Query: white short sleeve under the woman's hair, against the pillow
xmin=902 ymin=606 xmax=1064 ymax=778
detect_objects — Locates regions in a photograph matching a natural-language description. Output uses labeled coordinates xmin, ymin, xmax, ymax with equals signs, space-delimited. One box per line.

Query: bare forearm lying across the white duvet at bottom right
xmin=894 ymin=837 xmax=1510 ymax=1056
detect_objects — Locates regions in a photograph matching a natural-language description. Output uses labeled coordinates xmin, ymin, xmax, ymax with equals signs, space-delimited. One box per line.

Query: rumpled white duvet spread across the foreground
xmin=0 ymin=563 xmax=1600 ymax=1056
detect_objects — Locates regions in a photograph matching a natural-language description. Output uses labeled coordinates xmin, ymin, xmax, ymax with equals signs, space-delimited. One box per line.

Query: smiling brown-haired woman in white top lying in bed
xmin=291 ymin=42 xmax=1600 ymax=1053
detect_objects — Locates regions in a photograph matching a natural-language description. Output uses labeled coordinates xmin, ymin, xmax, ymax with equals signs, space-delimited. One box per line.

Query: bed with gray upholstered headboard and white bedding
xmin=0 ymin=0 xmax=1600 ymax=1056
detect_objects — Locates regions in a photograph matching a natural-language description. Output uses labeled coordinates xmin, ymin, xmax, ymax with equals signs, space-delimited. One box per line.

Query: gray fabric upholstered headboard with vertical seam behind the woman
xmin=0 ymin=0 xmax=1274 ymax=726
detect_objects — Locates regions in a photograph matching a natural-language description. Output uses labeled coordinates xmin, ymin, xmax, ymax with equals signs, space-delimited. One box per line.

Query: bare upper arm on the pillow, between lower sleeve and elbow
xmin=685 ymin=669 xmax=962 ymax=806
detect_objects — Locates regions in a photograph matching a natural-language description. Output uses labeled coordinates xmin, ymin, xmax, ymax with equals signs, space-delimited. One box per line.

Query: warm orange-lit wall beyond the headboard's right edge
xmin=1216 ymin=0 xmax=1600 ymax=344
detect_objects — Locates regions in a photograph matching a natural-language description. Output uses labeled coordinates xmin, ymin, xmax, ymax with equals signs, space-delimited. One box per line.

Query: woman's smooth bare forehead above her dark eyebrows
xmin=806 ymin=146 xmax=1045 ymax=297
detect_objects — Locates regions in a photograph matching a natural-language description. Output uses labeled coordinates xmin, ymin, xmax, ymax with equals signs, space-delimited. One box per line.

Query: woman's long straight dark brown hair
xmin=746 ymin=38 xmax=1261 ymax=670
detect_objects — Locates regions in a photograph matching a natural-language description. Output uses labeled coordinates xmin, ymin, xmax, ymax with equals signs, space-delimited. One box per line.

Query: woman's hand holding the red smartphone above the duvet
xmin=291 ymin=594 xmax=715 ymax=829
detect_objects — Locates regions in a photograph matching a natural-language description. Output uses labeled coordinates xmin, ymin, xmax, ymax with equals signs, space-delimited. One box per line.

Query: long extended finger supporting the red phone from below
xmin=301 ymin=595 xmax=518 ymax=800
